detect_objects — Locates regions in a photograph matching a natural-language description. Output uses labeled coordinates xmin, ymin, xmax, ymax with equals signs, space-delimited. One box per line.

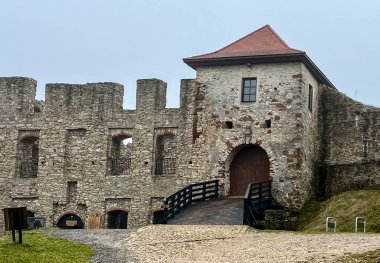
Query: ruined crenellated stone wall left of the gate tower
xmin=0 ymin=77 xmax=193 ymax=229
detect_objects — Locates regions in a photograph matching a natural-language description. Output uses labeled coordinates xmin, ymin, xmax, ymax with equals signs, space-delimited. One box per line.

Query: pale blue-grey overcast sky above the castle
xmin=0 ymin=0 xmax=380 ymax=108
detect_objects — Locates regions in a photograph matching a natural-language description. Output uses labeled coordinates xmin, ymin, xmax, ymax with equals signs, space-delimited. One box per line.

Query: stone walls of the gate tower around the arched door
xmin=193 ymin=63 xmax=318 ymax=209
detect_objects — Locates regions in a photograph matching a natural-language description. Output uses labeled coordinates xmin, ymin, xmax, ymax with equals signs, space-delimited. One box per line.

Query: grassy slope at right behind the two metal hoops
xmin=299 ymin=190 xmax=380 ymax=233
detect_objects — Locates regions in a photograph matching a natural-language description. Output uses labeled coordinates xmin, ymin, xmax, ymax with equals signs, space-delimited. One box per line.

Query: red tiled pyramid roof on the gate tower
xmin=185 ymin=25 xmax=305 ymax=60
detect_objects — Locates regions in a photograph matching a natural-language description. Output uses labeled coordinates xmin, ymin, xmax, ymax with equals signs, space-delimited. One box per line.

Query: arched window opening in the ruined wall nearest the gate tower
xmin=155 ymin=134 xmax=177 ymax=174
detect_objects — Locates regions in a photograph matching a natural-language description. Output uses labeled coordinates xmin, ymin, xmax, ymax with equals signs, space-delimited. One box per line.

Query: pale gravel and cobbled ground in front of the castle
xmin=46 ymin=225 xmax=380 ymax=263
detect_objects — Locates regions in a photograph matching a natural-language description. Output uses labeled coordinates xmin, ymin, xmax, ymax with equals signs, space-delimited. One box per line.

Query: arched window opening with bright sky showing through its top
xmin=111 ymin=136 xmax=133 ymax=175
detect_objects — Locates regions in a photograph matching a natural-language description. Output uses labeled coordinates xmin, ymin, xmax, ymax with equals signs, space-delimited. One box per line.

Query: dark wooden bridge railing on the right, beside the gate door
xmin=243 ymin=181 xmax=272 ymax=228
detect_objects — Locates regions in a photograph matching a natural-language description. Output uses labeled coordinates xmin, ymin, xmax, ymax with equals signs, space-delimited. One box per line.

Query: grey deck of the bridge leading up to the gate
xmin=168 ymin=198 xmax=244 ymax=225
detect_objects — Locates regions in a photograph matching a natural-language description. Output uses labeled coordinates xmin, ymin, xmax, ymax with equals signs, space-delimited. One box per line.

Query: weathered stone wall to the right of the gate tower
xmin=318 ymin=87 xmax=380 ymax=197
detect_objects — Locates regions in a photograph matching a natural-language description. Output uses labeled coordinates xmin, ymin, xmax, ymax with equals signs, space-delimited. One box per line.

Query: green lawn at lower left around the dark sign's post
xmin=0 ymin=230 xmax=95 ymax=263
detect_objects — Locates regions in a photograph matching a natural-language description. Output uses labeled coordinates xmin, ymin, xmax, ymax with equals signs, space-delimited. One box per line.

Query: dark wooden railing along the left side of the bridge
xmin=164 ymin=180 xmax=219 ymax=221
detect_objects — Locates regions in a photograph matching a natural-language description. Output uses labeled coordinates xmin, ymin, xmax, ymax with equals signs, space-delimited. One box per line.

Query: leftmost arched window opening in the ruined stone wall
xmin=18 ymin=137 xmax=39 ymax=178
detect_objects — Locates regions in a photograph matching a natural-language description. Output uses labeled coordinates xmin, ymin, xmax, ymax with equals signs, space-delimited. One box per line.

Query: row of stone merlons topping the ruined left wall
xmin=0 ymin=77 xmax=194 ymax=116
